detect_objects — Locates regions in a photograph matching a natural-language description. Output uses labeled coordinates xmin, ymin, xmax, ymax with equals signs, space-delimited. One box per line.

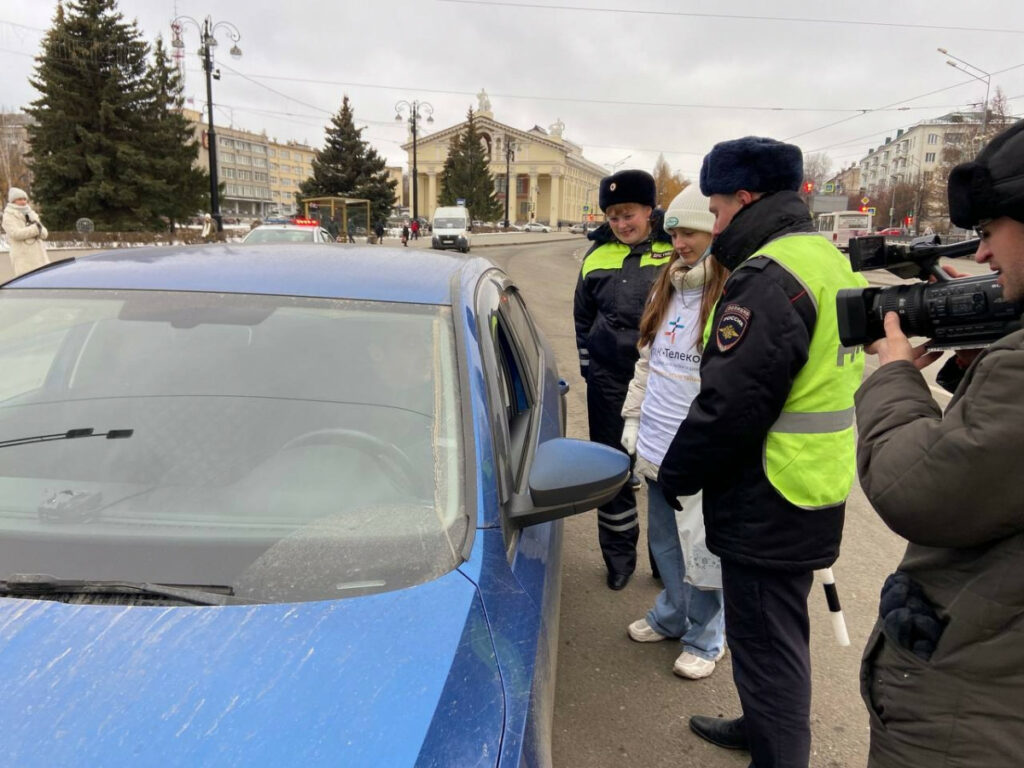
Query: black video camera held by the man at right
xmin=836 ymin=236 xmax=1024 ymax=349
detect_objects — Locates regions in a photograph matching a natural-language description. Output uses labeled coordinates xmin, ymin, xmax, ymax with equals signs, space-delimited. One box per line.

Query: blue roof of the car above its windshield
xmin=3 ymin=244 xmax=494 ymax=305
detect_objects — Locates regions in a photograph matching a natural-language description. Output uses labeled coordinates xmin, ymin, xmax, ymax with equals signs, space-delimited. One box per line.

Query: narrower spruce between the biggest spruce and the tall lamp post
xmin=144 ymin=37 xmax=210 ymax=229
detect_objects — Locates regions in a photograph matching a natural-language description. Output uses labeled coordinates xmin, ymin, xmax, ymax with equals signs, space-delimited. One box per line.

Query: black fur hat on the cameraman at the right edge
xmin=948 ymin=120 xmax=1024 ymax=229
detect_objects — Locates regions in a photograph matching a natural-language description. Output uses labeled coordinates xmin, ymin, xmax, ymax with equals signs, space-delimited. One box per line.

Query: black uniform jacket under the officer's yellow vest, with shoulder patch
xmin=658 ymin=191 xmax=846 ymax=571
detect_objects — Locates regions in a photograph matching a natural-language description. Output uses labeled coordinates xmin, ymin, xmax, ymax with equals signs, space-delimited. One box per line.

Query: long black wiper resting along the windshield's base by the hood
xmin=0 ymin=573 xmax=250 ymax=605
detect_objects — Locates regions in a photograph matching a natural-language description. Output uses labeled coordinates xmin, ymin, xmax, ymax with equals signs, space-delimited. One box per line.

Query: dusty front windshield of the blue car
xmin=0 ymin=290 xmax=469 ymax=602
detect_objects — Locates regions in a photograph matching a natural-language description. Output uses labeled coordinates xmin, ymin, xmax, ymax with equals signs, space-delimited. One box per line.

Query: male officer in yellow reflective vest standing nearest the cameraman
xmin=658 ymin=136 xmax=866 ymax=768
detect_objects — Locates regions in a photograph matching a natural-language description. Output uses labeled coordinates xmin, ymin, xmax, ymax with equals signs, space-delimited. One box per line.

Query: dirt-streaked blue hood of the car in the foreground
xmin=0 ymin=571 xmax=503 ymax=766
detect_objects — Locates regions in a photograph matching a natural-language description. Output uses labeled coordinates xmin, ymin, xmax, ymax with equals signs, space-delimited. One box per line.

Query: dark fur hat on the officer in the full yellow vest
xmin=700 ymin=136 xmax=804 ymax=197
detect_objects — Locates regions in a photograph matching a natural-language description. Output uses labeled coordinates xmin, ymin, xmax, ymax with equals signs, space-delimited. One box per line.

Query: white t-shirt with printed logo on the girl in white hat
xmin=637 ymin=288 xmax=703 ymax=466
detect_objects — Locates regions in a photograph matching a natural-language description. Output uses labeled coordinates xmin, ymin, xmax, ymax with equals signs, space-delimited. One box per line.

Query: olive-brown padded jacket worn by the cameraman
xmin=856 ymin=331 xmax=1024 ymax=766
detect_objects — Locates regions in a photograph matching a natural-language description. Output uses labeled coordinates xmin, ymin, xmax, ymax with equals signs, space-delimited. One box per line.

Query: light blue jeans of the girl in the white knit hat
xmin=647 ymin=480 xmax=725 ymax=659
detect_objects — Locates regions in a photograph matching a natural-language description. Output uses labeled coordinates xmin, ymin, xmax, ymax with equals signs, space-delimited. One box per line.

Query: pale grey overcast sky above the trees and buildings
xmin=0 ymin=0 xmax=1024 ymax=178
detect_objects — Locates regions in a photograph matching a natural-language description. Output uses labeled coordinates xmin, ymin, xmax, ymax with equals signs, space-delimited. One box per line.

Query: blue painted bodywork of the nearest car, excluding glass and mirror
xmin=0 ymin=246 xmax=577 ymax=766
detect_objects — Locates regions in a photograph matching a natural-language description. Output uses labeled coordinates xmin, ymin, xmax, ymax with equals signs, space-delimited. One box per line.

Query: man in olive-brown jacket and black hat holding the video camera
xmin=856 ymin=121 xmax=1024 ymax=768
